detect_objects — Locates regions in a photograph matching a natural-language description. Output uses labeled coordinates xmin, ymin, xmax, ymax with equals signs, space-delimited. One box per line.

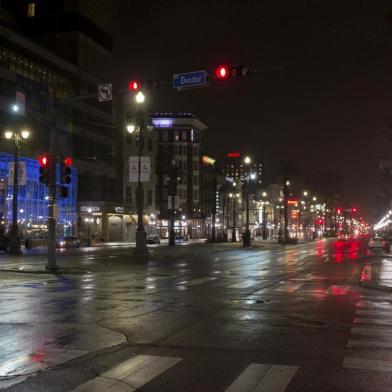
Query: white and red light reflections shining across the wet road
xmin=0 ymin=237 xmax=386 ymax=387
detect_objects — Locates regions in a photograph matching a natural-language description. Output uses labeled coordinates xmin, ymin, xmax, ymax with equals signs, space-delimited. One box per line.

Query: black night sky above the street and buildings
xmin=114 ymin=0 xmax=392 ymax=219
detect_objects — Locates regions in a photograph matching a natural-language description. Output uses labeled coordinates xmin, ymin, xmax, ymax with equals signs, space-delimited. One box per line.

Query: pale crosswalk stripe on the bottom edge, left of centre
xmin=74 ymin=355 xmax=181 ymax=392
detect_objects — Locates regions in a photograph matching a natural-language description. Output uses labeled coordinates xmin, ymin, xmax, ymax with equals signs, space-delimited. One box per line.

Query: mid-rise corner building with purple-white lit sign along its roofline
xmin=152 ymin=113 xmax=207 ymax=238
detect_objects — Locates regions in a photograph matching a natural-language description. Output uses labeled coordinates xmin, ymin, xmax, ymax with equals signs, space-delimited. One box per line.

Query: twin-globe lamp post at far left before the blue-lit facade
xmin=4 ymin=125 xmax=30 ymax=255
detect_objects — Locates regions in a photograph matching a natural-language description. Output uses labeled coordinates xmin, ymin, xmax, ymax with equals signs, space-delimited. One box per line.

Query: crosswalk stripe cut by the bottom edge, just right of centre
xmin=226 ymin=363 xmax=298 ymax=392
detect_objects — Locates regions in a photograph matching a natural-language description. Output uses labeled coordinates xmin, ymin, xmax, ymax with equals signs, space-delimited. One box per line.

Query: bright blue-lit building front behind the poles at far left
xmin=0 ymin=153 xmax=77 ymax=236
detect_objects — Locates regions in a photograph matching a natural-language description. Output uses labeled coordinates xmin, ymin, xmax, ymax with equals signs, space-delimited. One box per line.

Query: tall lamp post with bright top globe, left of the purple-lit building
xmin=126 ymin=91 xmax=150 ymax=257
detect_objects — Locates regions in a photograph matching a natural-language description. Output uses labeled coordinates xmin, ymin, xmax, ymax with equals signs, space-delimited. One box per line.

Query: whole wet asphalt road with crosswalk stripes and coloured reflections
xmin=0 ymin=240 xmax=392 ymax=392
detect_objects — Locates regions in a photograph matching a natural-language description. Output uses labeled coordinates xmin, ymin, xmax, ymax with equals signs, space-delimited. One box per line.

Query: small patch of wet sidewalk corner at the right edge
xmin=359 ymin=255 xmax=392 ymax=292
